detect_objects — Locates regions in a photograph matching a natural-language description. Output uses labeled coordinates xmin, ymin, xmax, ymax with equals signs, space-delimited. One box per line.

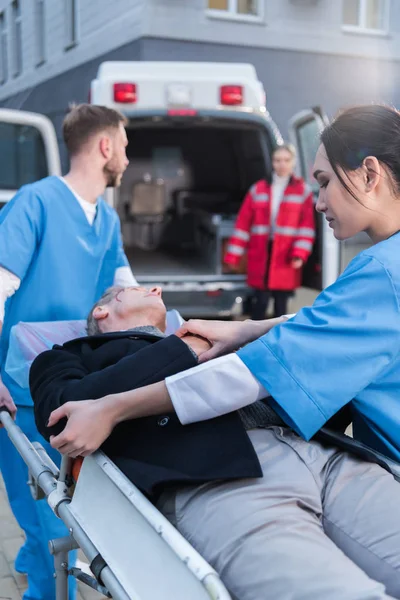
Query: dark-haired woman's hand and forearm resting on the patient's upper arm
xmin=176 ymin=317 xmax=287 ymax=362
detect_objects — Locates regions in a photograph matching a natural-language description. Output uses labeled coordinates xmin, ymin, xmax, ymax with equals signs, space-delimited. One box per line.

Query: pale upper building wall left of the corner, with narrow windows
xmin=0 ymin=0 xmax=149 ymax=99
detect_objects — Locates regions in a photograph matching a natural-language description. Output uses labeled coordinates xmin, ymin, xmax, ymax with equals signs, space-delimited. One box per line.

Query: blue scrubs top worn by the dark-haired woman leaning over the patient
xmin=238 ymin=233 xmax=400 ymax=460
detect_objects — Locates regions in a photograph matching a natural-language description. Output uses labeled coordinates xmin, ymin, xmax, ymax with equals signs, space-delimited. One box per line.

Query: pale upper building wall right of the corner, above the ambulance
xmin=143 ymin=0 xmax=400 ymax=59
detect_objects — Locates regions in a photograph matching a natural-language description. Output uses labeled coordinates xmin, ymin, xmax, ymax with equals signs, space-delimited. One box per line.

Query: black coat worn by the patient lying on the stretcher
xmin=30 ymin=332 xmax=262 ymax=499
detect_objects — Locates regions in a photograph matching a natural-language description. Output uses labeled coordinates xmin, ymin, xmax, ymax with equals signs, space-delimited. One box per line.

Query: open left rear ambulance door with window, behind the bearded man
xmin=0 ymin=108 xmax=61 ymax=205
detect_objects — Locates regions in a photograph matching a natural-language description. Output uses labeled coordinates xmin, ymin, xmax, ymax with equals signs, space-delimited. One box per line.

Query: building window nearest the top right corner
xmin=343 ymin=0 xmax=390 ymax=33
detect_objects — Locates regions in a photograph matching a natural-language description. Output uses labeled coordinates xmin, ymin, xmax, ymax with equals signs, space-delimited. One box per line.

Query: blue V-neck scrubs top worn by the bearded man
xmin=0 ymin=177 xmax=128 ymax=405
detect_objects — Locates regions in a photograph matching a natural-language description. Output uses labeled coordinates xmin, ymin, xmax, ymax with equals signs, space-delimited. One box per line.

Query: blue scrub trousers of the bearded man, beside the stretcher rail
xmin=0 ymin=406 xmax=76 ymax=600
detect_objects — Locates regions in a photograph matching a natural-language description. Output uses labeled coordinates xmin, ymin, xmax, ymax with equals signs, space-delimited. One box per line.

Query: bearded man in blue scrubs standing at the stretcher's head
xmin=0 ymin=104 xmax=136 ymax=600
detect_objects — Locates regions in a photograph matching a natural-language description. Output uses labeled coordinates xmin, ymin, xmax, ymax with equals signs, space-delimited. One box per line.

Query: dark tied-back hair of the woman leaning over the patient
xmin=321 ymin=104 xmax=400 ymax=195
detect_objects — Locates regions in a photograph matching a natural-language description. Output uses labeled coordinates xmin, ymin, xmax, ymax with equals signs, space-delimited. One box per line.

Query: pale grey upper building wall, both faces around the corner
xmin=0 ymin=0 xmax=400 ymax=101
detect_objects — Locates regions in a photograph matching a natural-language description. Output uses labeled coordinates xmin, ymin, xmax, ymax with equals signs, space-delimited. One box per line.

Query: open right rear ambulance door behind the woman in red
xmin=289 ymin=107 xmax=341 ymax=290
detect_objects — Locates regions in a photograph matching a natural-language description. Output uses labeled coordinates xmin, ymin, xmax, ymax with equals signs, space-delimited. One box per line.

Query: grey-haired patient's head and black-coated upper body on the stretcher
xmin=30 ymin=287 xmax=279 ymax=501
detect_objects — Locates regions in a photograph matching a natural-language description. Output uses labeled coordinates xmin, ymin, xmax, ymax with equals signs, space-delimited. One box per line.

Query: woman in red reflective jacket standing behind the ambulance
xmin=224 ymin=144 xmax=315 ymax=319
